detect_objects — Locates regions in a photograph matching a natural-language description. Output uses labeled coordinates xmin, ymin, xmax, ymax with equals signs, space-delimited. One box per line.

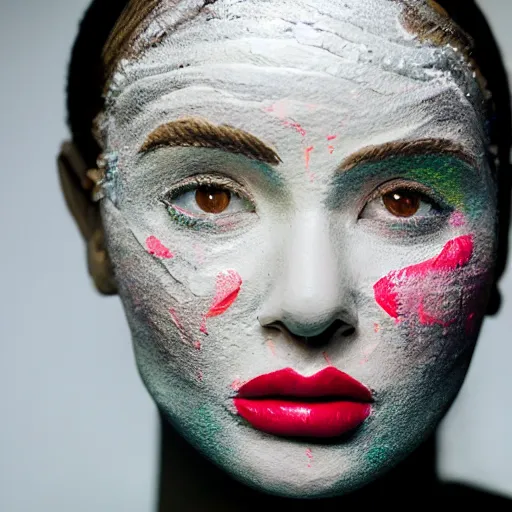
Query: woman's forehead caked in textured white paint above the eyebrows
xmin=104 ymin=0 xmax=484 ymax=160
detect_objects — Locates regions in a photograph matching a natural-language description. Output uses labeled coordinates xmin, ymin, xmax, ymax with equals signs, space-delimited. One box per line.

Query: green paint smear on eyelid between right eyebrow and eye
xmin=327 ymin=154 xmax=489 ymax=219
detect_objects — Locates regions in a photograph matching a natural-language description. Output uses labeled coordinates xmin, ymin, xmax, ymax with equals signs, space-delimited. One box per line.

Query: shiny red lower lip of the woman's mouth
xmin=234 ymin=398 xmax=371 ymax=437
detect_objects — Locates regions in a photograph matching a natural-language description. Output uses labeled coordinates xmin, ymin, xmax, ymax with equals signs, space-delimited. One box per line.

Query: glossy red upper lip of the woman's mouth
xmin=237 ymin=366 xmax=372 ymax=402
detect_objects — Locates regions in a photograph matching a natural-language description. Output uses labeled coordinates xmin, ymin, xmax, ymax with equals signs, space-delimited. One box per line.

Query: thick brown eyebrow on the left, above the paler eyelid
xmin=139 ymin=117 xmax=282 ymax=165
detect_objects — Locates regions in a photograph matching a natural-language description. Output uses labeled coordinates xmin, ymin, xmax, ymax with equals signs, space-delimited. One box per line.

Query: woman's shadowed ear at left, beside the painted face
xmin=57 ymin=142 xmax=117 ymax=295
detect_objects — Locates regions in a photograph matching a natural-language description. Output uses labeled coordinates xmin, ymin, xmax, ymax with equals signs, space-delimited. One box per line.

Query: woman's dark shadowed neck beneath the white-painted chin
xmin=158 ymin=417 xmax=437 ymax=512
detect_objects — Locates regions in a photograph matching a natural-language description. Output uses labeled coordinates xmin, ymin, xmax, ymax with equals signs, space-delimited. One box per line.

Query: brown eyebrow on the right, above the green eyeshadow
xmin=338 ymin=139 xmax=477 ymax=172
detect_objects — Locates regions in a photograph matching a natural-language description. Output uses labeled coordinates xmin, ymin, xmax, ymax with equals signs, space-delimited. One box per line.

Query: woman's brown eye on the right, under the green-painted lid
xmin=360 ymin=188 xmax=442 ymax=220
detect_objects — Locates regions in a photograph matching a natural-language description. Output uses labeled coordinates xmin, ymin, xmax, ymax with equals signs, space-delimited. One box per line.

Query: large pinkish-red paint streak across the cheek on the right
xmin=373 ymin=235 xmax=473 ymax=325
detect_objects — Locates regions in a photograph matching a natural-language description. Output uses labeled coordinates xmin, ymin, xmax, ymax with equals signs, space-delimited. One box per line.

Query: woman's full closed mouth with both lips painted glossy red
xmin=233 ymin=366 xmax=372 ymax=438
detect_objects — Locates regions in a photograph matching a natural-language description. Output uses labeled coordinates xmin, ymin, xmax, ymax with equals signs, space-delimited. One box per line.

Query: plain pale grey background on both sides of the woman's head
xmin=0 ymin=0 xmax=512 ymax=512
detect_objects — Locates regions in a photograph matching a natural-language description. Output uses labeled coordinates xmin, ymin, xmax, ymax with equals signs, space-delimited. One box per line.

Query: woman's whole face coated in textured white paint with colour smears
xmin=96 ymin=0 xmax=496 ymax=497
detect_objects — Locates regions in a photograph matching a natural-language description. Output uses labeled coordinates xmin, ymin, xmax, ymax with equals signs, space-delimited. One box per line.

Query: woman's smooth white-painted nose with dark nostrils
xmin=259 ymin=212 xmax=357 ymax=343
